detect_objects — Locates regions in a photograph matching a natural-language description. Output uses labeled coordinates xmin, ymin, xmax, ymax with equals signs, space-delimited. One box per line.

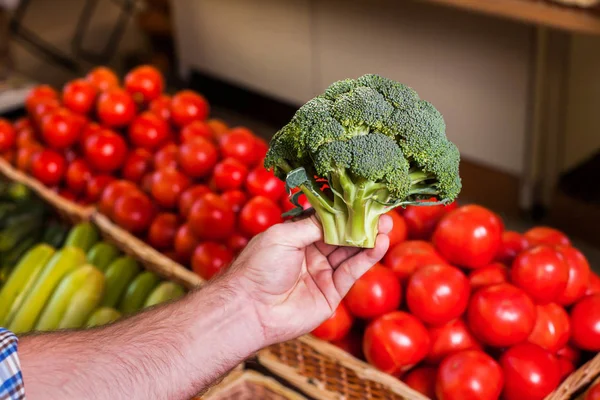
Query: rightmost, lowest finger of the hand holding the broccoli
xmin=333 ymin=234 xmax=390 ymax=297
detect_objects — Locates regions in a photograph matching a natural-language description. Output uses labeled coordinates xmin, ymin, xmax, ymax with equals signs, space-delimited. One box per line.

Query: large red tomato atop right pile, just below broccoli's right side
xmin=433 ymin=205 xmax=503 ymax=268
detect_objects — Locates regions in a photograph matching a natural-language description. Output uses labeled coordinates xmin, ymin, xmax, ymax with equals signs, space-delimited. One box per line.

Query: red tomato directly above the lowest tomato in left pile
xmin=188 ymin=193 xmax=235 ymax=240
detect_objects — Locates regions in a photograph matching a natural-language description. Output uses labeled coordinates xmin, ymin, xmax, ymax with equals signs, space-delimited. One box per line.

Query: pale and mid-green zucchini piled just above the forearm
xmin=0 ymin=222 xmax=185 ymax=333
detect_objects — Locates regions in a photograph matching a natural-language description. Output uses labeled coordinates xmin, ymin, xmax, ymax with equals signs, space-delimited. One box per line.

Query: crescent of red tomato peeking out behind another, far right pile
xmin=556 ymin=246 xmax=591 ymax=306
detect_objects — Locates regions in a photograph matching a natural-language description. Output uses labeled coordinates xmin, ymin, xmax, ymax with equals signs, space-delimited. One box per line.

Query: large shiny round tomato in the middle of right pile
xmin=467 ymin=283 xmax=536 ymax=347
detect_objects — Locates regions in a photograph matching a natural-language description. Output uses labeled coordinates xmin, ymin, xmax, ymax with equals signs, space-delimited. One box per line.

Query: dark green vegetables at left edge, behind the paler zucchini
xmin=0 ymin=180 xmax=68 ymax=286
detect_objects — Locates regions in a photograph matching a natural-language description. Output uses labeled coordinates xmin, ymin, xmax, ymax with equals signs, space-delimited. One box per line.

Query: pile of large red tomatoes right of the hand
xmin=313 ymin=204 xmax=600 ymax=400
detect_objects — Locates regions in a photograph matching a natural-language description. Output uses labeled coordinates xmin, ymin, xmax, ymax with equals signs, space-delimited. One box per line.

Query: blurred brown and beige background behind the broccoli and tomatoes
xmin=0 ymin=0 xmax=600 ymax=253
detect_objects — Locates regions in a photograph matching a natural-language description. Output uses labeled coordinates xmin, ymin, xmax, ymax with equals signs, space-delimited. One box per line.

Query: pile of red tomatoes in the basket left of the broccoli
xmin=0 ymin=66 xmax=292 ymax=279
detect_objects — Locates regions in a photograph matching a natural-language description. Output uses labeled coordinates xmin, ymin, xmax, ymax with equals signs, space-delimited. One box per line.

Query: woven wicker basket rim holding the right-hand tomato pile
xmin=258 ymin=336 xmax=600 ymax=400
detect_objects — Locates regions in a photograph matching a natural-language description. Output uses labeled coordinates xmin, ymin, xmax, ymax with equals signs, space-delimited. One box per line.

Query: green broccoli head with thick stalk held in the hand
xmin=265 ymin=75 xmax=461 ymax=248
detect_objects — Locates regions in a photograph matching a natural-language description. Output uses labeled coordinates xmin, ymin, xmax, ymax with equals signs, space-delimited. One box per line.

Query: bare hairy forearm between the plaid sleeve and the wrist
xmin=19 ymin=281 xmax=263 ymax=400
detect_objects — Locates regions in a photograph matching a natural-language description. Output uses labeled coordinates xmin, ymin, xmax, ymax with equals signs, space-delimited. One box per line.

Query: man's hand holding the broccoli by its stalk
xmin=223 ymin=215 xmax=392 ymax=346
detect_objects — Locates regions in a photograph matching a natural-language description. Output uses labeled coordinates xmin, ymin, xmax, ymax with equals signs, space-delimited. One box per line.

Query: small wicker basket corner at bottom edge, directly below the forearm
xmin=198 ymin=371 xmax=305 ymax=400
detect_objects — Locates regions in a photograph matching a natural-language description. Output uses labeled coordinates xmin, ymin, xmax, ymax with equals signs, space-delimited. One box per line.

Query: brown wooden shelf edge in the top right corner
xmin=422 ymin=0 xmax=600 ymax=35
